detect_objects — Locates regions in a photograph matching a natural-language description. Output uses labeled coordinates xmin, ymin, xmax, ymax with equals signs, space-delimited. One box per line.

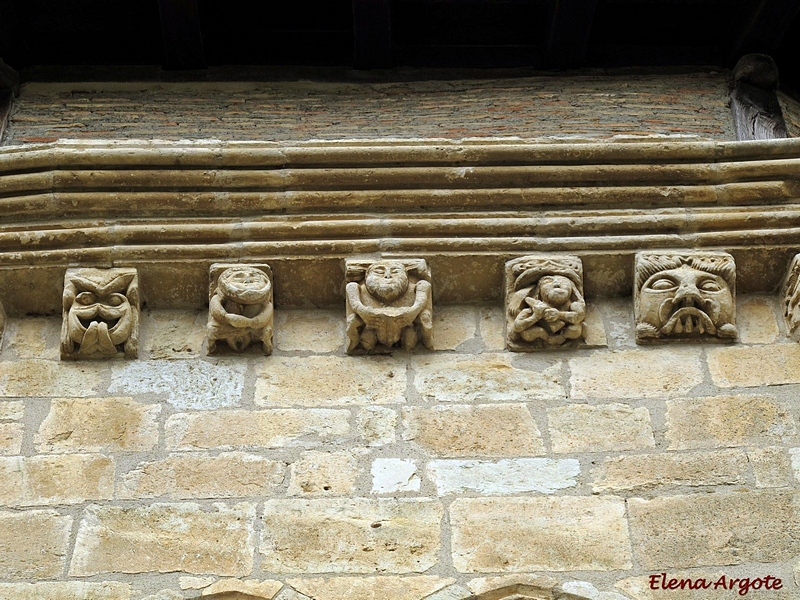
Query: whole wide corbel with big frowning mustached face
xmin=634 ymin=252 xmax=736 ymax=344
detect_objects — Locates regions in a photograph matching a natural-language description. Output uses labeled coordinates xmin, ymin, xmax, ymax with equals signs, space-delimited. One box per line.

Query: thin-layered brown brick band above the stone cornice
xmin=3 ymin=72 xmax=736 ymax=145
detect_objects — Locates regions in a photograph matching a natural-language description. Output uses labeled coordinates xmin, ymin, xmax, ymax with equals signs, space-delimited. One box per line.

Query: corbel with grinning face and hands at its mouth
xmin=61 ymin=268 xmax=139 ymax=359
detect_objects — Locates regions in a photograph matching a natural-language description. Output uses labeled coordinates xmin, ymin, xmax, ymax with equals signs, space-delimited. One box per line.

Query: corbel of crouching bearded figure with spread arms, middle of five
xmin=346 ymin=259 xmax=433 ymax=354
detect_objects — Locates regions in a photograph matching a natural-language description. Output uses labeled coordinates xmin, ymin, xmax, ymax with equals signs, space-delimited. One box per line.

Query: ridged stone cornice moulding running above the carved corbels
xmin=0 ymin=138 xmax=800 ymax=313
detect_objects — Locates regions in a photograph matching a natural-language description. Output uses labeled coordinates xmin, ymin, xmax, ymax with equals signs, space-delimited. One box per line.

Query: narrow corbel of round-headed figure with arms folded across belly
xmin=207 ymin=264 xmax=274 ymax=354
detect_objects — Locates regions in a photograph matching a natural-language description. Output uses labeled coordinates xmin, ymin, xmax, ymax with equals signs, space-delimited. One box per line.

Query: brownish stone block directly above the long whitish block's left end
xmin=403 ymin=404 xmax=544 ymax=457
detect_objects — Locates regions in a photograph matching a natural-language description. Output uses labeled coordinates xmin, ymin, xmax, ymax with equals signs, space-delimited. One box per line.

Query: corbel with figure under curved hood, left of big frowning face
xmin=506 ymin=255 xmax=586 ymax=351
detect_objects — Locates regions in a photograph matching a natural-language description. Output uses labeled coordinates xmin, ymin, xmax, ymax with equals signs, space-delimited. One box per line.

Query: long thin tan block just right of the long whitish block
xmin=592 ymin=450 xmax=748 ymax=493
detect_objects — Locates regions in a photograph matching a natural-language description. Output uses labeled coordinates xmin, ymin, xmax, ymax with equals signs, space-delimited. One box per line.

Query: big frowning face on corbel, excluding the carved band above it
xmin=638 ymin=264 xmax=735 ymax=338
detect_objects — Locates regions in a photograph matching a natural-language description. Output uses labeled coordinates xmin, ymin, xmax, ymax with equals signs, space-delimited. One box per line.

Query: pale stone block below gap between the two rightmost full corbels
xmin=569 ymin=348 xmax=703 ymax=400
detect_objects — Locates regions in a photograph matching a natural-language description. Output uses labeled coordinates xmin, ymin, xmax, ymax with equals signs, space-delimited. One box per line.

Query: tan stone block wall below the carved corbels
xmin=0 ymin=296 xmax=800 ymax=600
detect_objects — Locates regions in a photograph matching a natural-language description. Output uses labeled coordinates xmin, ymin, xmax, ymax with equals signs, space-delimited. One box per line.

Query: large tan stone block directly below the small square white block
xmin=259 ymin=498 xmax=443 ymax=574
